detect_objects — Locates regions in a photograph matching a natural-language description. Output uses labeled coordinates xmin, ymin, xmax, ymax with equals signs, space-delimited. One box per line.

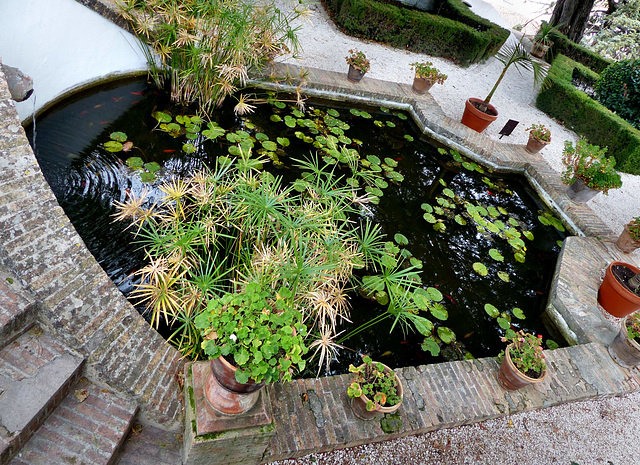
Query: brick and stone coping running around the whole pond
xmin=0 ymin=9 xmax=639 ymax=460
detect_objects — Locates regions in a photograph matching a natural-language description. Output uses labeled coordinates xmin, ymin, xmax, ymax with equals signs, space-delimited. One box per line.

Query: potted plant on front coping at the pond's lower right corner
xmin=498 ymin=330 xmax=547 ymax=391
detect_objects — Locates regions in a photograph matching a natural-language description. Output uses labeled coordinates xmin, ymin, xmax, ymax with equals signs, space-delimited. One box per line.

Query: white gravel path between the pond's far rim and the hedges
xmin=279 ymin=0 xmax=640 ymax=233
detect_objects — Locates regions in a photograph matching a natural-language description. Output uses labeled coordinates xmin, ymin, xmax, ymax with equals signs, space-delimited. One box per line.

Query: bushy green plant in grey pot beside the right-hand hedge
xmin=562 ymin=138 xmax=622 ymax=202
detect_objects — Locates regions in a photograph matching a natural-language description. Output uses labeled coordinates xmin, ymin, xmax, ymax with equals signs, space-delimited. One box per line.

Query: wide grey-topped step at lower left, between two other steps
xmin=0 ymin=326 xmax=84 ymax=465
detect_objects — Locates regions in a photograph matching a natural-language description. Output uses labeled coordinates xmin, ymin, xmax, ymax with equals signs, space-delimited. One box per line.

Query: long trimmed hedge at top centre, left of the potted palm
xmin=322 ymin=0 xmax=509 ymax=65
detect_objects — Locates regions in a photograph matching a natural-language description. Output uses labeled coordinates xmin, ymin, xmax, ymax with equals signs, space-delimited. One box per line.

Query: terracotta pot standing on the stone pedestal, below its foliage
xmin=204 ymin=357 xmax=264 ymax=415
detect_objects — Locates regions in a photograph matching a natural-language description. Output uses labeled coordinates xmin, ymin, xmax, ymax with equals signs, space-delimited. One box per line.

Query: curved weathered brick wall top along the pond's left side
xmin=0 ymin=59 xmax=183 ymax=428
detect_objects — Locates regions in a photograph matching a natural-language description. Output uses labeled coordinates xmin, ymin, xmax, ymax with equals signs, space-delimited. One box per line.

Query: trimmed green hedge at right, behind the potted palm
xmin=536 ymin=55 xmax=640 ymax=174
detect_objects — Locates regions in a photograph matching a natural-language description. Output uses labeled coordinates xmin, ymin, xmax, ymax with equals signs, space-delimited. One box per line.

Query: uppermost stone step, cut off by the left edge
xmin=0 ymin=267 xmax=36 ymax=349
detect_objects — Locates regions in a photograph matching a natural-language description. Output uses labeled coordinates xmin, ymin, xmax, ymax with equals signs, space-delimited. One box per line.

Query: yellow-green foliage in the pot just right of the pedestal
xmin=347 ymin=356 xmax=402 ymax=412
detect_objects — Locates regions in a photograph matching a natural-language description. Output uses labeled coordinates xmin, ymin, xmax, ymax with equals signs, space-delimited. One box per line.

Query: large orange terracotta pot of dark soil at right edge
xmin=598 ymin=262 xmax=640 ymax=318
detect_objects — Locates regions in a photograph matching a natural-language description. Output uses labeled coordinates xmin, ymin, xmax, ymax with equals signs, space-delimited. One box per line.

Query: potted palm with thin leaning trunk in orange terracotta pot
xmin=461 ymin=36 xmax=548 ymax=132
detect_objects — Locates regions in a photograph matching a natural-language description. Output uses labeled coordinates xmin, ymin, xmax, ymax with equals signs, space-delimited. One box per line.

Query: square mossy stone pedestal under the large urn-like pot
xmin=183 ymin=362 xmax=275 ymax=465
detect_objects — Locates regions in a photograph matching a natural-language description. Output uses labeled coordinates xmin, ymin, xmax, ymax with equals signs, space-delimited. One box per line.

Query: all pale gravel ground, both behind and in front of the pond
xmin=268 ymin=0 xmax=640 ymax=465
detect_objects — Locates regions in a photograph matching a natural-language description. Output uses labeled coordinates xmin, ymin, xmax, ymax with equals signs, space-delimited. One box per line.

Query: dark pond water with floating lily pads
xmin=27 ymin=76 xmax=564 ymax=373
